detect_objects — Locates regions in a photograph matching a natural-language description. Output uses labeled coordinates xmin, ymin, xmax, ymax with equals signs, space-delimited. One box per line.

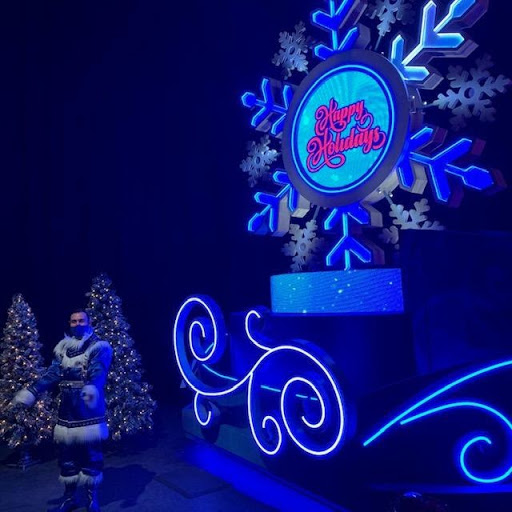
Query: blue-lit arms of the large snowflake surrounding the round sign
xmin=242 ymin=0 xmax=509 ymax=269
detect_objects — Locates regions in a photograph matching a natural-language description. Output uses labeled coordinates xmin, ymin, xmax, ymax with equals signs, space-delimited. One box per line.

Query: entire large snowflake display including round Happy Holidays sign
xmin=242 ymin=0 xmax=509 ymax=271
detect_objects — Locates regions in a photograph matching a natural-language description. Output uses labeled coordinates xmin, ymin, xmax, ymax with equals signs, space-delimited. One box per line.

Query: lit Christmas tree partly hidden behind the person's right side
xmin=87 ymin=274 xmax=156 ymax=440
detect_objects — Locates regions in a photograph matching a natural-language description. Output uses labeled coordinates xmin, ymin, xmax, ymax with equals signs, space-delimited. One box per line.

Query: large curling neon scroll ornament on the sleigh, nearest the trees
xmin=173 ymin=296 xmax=346 ymax=457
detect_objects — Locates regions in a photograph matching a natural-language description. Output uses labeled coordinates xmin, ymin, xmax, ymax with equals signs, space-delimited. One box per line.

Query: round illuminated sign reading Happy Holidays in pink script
xmin=283 ymin=50 xmax=409 ymax=207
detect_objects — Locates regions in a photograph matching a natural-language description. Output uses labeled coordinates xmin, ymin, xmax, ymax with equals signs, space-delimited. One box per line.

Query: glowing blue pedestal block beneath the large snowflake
xmin=270 ymin=268 xmax=404 ymax=315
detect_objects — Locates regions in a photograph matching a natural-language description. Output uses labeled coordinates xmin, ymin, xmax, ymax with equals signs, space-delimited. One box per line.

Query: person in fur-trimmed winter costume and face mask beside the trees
xmin=14 ymin=311 xmax=112 ymax=512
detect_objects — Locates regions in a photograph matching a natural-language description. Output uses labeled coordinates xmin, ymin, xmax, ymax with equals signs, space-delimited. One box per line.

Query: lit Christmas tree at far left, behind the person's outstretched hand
xmin=0 ymin=295 xmax=56 ymax=450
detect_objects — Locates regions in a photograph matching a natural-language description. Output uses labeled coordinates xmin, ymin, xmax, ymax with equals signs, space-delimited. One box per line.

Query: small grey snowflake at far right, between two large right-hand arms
xmin=433 ymin=55 xmax=511 ymax=130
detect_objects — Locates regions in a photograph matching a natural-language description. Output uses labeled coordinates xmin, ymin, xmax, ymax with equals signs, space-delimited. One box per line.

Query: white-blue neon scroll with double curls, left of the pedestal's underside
xmin=173 ymin=297 xmax=345 ymax=457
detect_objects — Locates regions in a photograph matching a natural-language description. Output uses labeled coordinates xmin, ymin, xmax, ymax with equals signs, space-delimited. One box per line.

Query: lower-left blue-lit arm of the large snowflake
xmin=247 ymin=169 xmax=300 ymax=235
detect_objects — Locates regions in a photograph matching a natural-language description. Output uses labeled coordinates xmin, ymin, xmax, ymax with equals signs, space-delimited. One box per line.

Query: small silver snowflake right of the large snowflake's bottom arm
xmin=379 ymin=198 xmax=444 ymax=248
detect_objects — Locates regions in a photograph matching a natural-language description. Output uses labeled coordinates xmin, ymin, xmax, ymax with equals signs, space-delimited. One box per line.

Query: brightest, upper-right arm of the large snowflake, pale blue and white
xmin=390 ymin=0 xmax=487 ymax=89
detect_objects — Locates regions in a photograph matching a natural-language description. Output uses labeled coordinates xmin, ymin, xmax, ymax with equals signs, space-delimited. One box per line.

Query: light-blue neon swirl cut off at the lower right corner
xmin=363 ymin=360 xmax=512 ymax=484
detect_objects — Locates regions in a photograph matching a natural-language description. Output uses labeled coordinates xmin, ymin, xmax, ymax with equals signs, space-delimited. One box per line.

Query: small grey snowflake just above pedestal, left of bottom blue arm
xmin=282 ymin=220 xmax=324 ymax=272
